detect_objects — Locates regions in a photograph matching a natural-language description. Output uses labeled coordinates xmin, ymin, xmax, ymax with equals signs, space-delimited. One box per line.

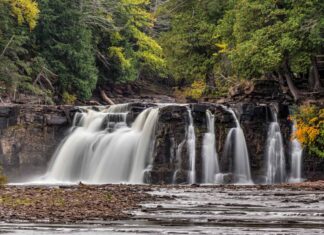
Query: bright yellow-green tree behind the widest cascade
xmin=94 ymin=0 xmax=165 ymax=84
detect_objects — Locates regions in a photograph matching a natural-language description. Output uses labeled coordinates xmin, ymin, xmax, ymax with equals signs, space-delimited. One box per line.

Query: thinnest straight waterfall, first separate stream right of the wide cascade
xmin=187 ymin=108 xmax=196 ymax=184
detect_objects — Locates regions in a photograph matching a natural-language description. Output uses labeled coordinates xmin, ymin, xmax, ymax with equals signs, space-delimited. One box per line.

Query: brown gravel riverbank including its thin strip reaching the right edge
xmin=0 ymin=181 xmax=324 ymax=223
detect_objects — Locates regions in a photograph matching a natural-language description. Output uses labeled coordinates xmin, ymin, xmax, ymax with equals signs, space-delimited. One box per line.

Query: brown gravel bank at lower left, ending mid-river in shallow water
xmin=0 ymin=185 xmax=157 ymax=223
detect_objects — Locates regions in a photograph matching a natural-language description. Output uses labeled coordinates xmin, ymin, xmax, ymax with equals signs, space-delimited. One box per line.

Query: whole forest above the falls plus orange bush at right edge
xmin=0 ymin=0 xmax=324 ymax=156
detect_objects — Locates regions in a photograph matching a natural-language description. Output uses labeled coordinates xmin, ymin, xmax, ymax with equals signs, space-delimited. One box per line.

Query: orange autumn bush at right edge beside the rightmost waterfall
xmin=291 ymin=105 xmax=324 ymax=157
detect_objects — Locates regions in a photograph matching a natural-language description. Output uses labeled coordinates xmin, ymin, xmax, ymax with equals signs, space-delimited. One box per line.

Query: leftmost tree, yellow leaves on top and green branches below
xmin=0 ymin=0 xmax=39 ymax=97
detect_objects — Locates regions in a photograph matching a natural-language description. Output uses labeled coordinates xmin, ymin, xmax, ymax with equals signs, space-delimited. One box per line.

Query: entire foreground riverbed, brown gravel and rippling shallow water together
xmin=0 ymin=181 xmax=324 ymax=234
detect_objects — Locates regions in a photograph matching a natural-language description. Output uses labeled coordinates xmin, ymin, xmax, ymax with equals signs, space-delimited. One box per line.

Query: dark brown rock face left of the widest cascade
xmin=0 ymin=105 xmax=73 ymax=179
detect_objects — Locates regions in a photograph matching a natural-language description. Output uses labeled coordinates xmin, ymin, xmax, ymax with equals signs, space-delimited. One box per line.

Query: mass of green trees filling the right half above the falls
xmin=160 ymin=0 xmax=324 ymax=100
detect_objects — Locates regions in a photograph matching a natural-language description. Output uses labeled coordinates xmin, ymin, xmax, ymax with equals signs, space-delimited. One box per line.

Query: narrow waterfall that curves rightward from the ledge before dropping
xmin=223 ymin=106 xmax=253 ymax=184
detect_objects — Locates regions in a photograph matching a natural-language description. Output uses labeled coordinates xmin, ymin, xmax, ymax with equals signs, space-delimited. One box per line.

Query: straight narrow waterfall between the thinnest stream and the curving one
xmin=202 ymin=110 xmax=219 ymax=183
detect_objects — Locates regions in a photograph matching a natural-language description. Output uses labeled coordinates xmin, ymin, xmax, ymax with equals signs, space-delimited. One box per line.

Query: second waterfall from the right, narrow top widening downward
xmin=265 ymin=113 xmax=286 ymax=184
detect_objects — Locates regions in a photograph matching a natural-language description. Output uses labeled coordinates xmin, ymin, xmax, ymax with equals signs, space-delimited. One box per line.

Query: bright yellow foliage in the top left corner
xmin=10 ymin=0 xmax=39 ymax=30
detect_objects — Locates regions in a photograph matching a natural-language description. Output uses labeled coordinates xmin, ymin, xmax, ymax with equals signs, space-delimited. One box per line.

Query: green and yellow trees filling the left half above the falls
xmin=0 ymin=0 xmax=165 ymax=103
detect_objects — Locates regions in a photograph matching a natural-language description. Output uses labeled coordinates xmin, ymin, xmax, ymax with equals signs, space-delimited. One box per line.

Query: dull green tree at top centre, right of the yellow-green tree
xmin=160 ymin=0 xmax=229 ymax=97
